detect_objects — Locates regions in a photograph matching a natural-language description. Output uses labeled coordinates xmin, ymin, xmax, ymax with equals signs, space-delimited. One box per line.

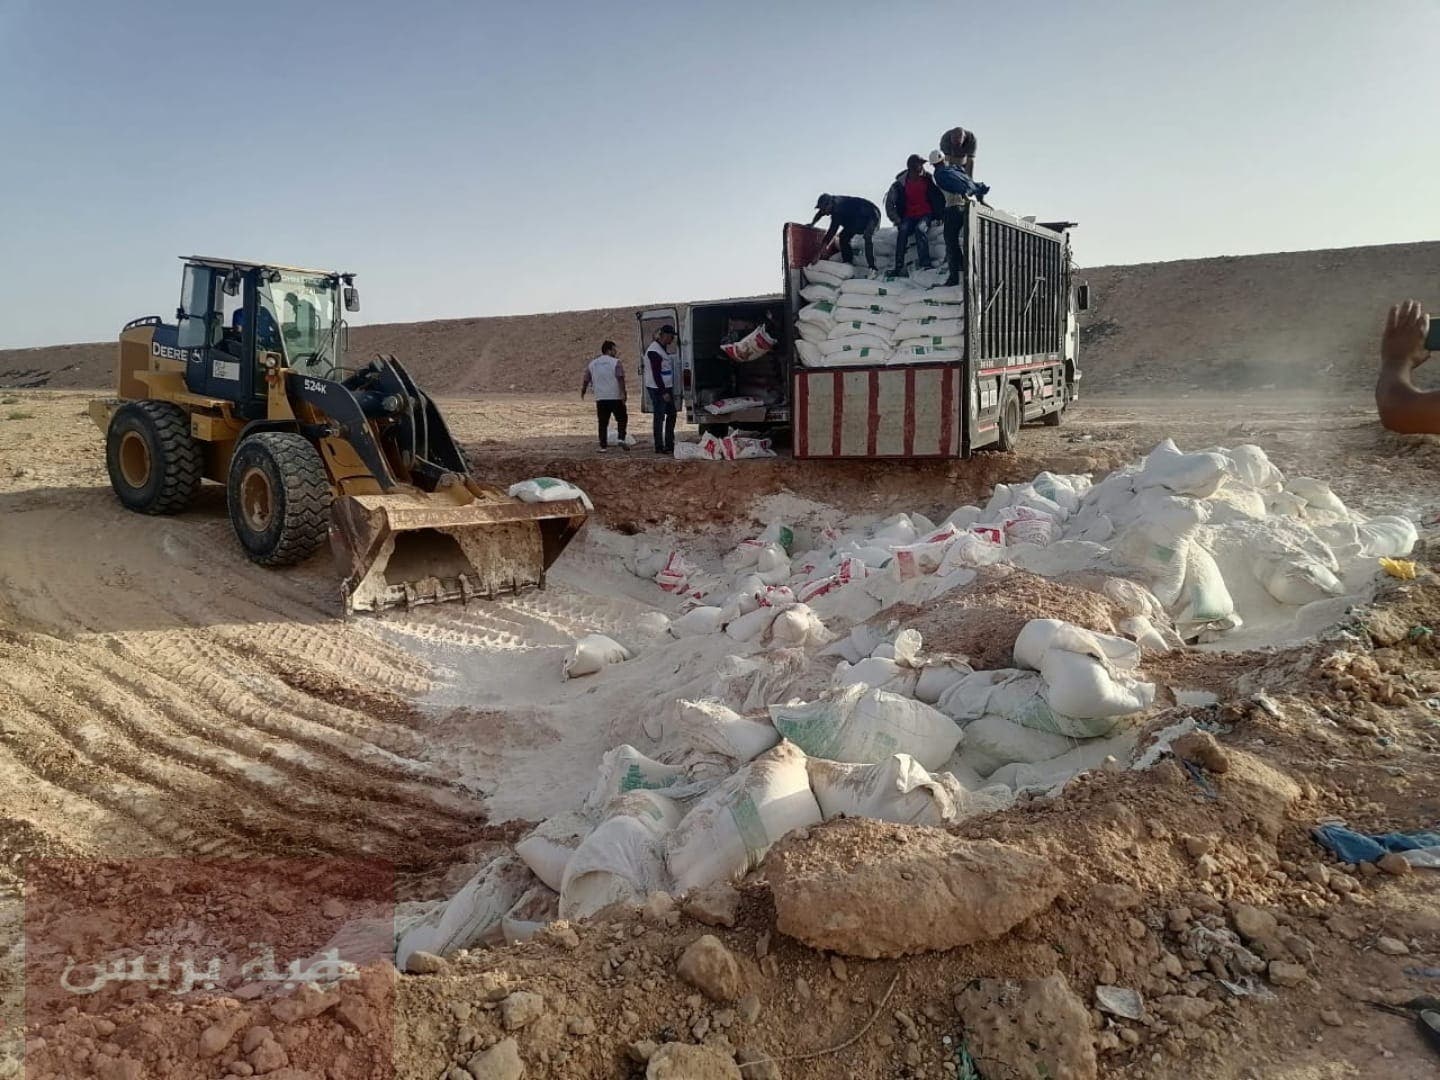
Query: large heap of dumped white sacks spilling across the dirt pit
xmin=397 ymin=441 xmax=1417 ymax=966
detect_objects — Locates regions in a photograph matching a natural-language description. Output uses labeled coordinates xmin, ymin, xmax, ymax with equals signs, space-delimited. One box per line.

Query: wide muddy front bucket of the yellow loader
xmin=330 ymin=488 xmax=586 ymax=611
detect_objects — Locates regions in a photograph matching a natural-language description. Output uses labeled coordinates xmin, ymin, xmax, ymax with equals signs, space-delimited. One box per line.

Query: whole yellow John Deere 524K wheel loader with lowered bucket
xmin=89 ymin=256 xmax=586 ymax=611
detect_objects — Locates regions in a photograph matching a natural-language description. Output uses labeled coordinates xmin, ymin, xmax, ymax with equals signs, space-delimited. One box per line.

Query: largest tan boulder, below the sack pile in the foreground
xmin=765 ymin=818 xmax=1061 ymax=959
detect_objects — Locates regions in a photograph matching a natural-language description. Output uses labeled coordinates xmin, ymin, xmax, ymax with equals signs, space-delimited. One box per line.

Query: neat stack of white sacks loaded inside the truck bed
xmin=795 ymin=261 xmax=965 ymax=367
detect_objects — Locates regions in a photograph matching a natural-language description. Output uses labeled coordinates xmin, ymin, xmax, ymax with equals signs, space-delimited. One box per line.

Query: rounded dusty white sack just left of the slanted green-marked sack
xmin=560 ymin=815 xmax=670 ymax=919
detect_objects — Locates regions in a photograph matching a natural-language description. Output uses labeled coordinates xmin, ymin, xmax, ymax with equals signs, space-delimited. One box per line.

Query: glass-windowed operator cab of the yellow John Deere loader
xmin=174 ymin=256 xmax=359 ymax=419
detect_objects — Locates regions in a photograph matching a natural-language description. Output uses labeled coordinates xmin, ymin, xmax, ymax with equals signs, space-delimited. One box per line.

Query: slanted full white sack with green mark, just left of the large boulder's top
xmin=665 ymin=743 xmax=821 ymax=893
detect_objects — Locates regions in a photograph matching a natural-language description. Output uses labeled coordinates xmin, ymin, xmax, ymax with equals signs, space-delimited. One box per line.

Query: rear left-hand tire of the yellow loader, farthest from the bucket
xmin=105 ymin=402 xmax=204 ymax=514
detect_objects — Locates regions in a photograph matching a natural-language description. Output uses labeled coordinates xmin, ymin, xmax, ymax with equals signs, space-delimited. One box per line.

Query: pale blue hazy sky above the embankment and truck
xmin=0 ymin=0 xmax=1440 ymax=347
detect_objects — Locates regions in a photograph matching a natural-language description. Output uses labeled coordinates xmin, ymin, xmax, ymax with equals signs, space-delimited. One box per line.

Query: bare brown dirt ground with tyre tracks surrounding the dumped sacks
xmin=0 ymin=390 xmax=1440 ymax=1080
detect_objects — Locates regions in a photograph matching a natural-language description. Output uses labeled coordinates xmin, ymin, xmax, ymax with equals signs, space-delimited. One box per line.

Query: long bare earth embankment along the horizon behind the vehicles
xmin=0 ymin=242 xmax=1440 ymax=395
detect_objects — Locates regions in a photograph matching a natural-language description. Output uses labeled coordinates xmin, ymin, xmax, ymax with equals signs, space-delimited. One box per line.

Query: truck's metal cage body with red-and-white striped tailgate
xmin=783 ymin=203 xmax=1080 ymax=458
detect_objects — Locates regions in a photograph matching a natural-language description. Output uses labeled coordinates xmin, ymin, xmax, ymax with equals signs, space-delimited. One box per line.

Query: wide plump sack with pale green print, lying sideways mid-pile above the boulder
xmin=770 ymin=685 xmax=963 ymax=769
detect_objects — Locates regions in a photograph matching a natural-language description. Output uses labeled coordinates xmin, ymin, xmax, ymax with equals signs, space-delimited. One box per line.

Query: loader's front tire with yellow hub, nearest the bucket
xmin=226 ymin=431 xmax=331 ymax=566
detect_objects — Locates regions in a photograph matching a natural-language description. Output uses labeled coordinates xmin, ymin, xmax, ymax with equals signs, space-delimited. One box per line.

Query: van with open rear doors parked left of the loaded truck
xmin=635 ymin=294 xmax=793 ymax=431
